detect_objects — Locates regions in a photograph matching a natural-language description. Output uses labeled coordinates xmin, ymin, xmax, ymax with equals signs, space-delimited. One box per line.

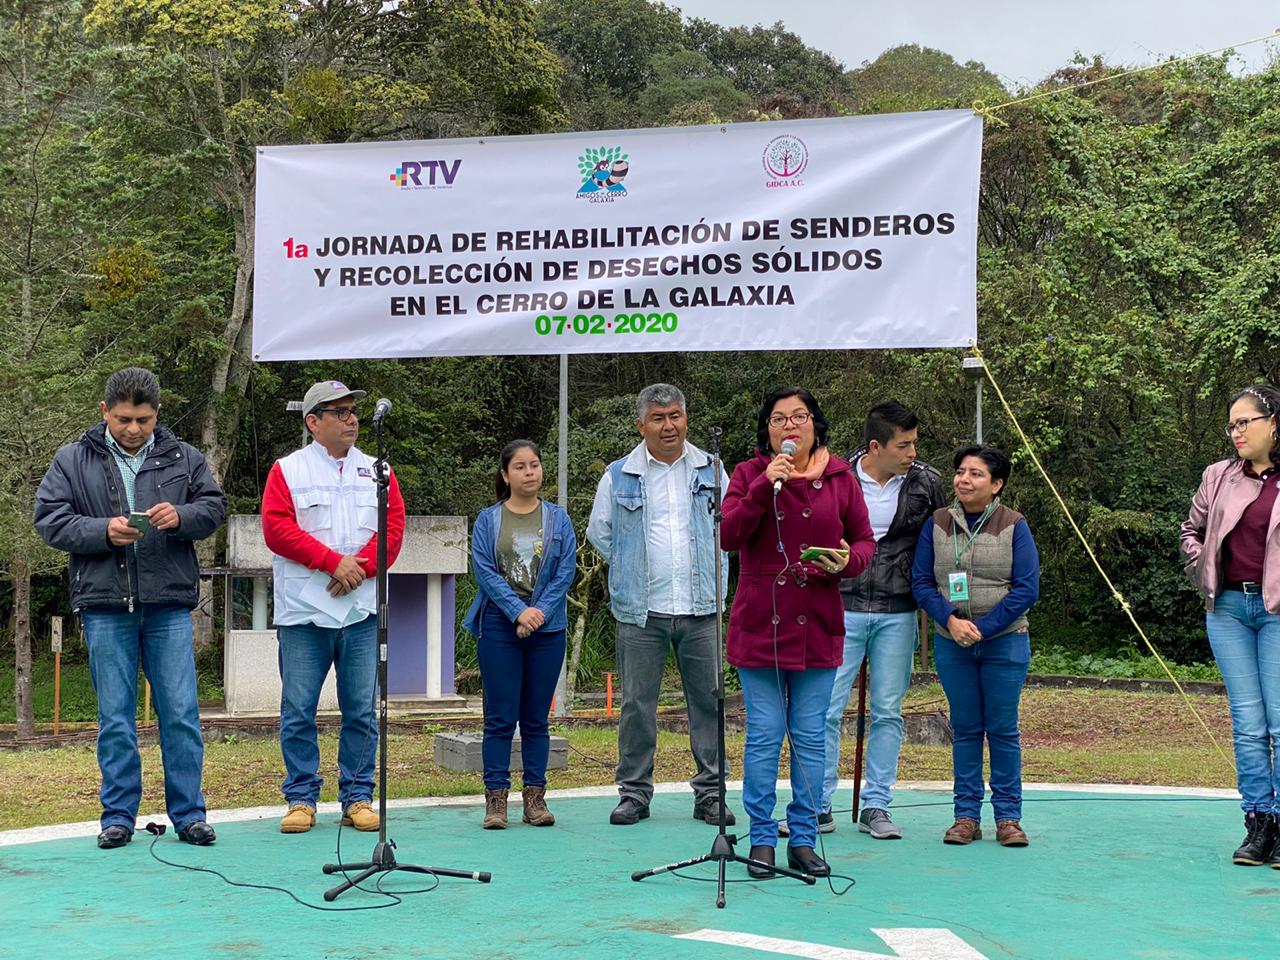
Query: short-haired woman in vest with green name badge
xmin=911 ymin=445 xmax=1039 ymax=846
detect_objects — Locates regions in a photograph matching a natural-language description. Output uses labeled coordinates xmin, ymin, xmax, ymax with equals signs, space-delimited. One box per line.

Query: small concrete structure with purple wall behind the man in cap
xmin=221 ymin=515 xmax=470 ymax=717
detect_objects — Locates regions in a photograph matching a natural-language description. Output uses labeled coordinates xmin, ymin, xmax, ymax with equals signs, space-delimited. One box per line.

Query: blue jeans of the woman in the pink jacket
xmin=1204 ymin=590 xmax=1280 ymax=813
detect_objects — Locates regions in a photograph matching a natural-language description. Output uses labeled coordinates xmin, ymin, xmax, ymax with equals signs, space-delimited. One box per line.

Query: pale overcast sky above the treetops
xmin=669 ymin=0 xmax=1280 ymax=88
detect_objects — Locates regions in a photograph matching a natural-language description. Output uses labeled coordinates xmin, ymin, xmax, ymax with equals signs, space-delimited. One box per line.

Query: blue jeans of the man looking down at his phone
xmin=81 ymin=603 xmax=205 ymax=832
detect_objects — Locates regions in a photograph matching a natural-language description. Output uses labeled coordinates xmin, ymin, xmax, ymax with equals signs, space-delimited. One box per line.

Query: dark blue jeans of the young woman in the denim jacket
xmin=476 ymin=604 xmax=564 ymax=790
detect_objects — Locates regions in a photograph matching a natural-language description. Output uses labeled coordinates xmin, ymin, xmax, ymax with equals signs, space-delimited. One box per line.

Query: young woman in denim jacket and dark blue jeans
xmin=465 ymin=440 xmax=577 ymax=829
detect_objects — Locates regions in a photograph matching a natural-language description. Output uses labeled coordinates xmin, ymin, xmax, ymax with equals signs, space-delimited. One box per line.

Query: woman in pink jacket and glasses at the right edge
xmin=1181 ymin=384 xmax=1280 ymax=869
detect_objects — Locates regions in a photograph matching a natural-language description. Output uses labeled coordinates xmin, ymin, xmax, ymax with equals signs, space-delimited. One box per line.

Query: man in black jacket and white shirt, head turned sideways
xmin=818 ymin=401 xmax=946 ymax=840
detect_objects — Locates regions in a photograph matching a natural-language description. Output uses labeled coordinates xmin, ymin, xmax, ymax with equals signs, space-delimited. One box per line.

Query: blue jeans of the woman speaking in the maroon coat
xmin=737 ymin=667 xmax=836 ymax=846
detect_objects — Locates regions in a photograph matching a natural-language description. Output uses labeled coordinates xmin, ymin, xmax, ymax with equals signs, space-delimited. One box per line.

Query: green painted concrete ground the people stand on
xmin=0 ymin=788 xmax=1280 ymax=960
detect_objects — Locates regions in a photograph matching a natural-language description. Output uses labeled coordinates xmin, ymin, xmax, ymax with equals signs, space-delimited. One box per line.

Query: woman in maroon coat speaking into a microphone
xmin=721 ymin=387 xmax=876 ymax=877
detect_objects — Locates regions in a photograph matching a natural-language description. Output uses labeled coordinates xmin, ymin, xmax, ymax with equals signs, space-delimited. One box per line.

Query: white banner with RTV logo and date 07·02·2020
xmin=253 ymin=110 xmax=982 ymax=360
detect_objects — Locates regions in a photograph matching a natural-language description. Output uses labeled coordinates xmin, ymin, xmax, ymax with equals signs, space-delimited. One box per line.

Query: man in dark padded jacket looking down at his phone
xmin=36 ymin=367 xmax=227 ymax=850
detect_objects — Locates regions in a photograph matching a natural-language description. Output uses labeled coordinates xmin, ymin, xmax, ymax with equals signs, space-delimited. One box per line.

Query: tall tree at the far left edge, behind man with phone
xmin=0 ymin=0 xmax=124 ymax=737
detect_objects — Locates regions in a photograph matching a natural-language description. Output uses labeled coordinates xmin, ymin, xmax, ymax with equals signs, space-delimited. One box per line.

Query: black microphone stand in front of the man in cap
xmin=321 ymin=416 xmax=490 ymax=902
